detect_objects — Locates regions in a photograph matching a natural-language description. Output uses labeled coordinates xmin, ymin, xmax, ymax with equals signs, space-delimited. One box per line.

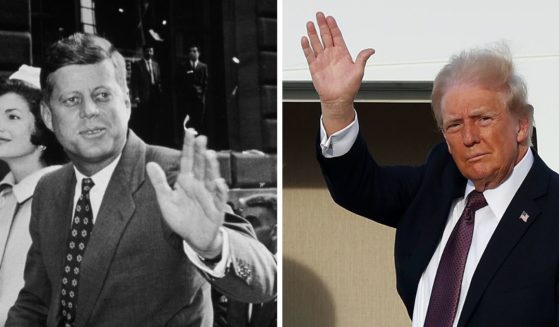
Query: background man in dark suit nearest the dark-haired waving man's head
xmin=130 ymin=45 xmax=163 ymax=143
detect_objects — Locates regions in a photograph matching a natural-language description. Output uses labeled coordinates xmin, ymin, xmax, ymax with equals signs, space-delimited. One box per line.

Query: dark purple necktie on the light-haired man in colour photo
xmin=424 ymin=191 xmax=487 ymax=327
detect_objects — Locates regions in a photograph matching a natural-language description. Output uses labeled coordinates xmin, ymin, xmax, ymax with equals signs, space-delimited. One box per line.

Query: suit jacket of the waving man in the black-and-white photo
xmin=7 ymin=131 xmax=276 ymax=327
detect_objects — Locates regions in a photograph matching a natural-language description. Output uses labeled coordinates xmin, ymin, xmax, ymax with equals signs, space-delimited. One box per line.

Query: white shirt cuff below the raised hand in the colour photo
xmin=320 ymin=109 xmax=359 ymax=158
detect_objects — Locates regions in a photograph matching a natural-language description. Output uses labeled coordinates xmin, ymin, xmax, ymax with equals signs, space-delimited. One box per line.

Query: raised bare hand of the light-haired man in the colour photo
xmin=301 ymin=12 xmax=375 ymax=135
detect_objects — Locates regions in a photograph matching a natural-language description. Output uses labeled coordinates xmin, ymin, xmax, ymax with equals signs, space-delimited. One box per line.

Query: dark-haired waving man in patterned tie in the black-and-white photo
xmin=6 ymin=34 xmax=276 ymax=327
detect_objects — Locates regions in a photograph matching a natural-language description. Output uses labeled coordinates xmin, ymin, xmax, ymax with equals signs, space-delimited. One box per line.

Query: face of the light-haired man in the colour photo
xmin=441 ymin=84 xmax=529 ymax=191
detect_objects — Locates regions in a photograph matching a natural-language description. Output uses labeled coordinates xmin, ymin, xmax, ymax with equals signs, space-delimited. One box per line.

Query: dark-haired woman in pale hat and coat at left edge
xmin=0 ymin=65 xmax=66 ymax=326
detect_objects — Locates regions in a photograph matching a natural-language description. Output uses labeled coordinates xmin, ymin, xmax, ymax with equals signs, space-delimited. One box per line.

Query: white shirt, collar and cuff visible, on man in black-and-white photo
xmin=70 ymin=155 xmax=231 ymax=278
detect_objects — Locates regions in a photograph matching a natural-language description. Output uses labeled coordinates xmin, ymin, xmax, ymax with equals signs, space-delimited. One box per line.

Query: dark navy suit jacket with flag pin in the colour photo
xmin=317 ymin=136 xmax=559 ymax=326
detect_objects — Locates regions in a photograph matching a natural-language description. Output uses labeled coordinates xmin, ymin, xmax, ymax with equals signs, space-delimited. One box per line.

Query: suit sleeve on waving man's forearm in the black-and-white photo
xmin=203 ymin=213 xmax=277 ymax=302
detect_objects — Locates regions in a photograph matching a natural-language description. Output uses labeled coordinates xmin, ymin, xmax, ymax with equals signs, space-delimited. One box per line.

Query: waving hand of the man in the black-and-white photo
xmin=147 ymin=130 xmax=231 ymax=258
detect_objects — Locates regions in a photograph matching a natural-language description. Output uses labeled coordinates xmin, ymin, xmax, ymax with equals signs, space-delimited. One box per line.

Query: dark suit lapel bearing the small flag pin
xmin=458 ymin=154 xmax=550 ymax=326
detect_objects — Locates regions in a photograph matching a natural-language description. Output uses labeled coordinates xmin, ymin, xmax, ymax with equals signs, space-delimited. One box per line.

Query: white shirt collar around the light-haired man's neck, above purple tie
xmin=464 ymin=148 xmax=534 ymax=219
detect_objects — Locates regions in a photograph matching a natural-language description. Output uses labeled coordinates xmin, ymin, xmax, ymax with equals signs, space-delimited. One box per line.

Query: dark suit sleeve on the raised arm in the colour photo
xmin=316 ymin=135 xmax=425 ymax=227
